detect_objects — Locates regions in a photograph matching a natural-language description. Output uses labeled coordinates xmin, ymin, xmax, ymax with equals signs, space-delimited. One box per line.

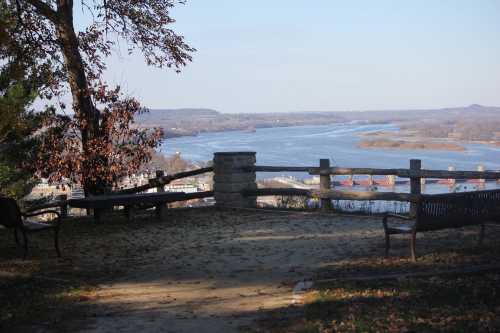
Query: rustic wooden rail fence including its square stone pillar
xmin=26 ymin=152 xmax=500 ymax=213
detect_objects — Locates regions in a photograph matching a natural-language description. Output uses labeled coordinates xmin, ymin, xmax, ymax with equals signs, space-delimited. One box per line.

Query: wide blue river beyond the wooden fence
xmin=161 ymin=123 xmax=500 ymax=174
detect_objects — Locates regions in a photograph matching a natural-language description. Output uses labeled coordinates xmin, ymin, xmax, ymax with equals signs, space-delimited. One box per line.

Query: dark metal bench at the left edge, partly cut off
xmin=0 ymin=197 xmax=61 ymax=259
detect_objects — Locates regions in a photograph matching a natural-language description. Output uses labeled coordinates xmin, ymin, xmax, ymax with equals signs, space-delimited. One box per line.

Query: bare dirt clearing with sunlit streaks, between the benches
xmin=0 ymin=208 xmax=499 ymax=332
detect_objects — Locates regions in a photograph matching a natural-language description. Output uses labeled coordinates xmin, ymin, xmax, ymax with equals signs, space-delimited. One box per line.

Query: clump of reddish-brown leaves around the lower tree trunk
xmin=35 ymin=82 xmax=161 ymax=186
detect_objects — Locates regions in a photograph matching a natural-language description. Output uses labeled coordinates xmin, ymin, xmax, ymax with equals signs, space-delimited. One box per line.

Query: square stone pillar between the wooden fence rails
xmin=214 ymin=152 xmax=257 ymax=208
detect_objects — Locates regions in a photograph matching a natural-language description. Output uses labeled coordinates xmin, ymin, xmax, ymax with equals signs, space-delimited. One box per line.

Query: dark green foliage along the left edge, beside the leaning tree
xmin=0 ymin=1 xmax=45 ymax=198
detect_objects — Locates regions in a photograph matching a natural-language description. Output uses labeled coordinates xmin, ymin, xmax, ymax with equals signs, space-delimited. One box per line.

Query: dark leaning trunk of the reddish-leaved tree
xmin=56 ymin=0 xmax=107 ymax=196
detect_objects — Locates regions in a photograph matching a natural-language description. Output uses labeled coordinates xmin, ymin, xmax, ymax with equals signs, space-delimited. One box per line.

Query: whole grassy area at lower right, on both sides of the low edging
xmin=250 ymin=244 xmax=500 ymax=333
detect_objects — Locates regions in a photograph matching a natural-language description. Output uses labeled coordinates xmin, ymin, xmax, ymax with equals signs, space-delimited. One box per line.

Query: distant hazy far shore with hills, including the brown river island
xmin=136 ymin=104 xmax=500 ymax=151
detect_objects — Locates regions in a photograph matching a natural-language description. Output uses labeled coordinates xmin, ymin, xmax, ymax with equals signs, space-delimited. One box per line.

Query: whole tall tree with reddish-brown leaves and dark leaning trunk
xmin=2 ymin=0 xmax=194 ymax=194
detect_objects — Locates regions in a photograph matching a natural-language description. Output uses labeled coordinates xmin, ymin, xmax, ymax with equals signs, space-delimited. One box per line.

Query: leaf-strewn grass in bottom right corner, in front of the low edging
xmin=256 ymin=273 xmax=500 ymax=333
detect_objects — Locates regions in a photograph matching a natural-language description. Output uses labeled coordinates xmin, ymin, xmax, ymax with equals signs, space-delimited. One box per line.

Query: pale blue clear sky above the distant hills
xmin=77 ymin=0 xmax=500 ymax=113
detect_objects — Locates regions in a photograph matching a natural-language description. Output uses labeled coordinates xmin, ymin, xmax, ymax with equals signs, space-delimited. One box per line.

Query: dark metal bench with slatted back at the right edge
xmin=382 ymin=190 xmax=500 ymax=261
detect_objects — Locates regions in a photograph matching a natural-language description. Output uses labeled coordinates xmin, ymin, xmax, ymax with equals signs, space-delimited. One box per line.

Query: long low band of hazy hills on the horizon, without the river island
xmin=136 ymin=104 xmax=500 ymax=138
